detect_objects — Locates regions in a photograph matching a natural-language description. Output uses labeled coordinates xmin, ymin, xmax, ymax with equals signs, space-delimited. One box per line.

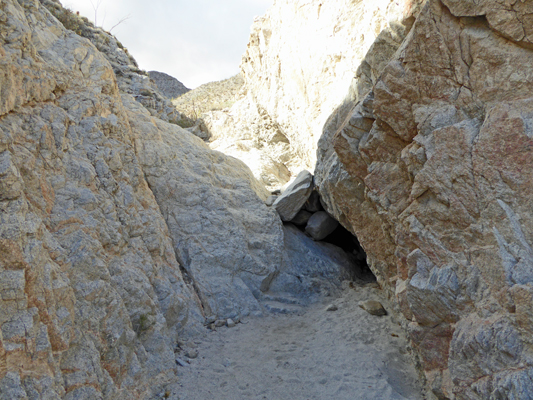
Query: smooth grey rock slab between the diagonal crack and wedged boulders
xmin=123 ymin=95 xmax=283 ymax=319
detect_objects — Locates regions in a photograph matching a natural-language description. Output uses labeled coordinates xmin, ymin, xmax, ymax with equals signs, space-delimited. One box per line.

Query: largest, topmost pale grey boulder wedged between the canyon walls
xmin=273 ymin=171 xmax=313 ymax=221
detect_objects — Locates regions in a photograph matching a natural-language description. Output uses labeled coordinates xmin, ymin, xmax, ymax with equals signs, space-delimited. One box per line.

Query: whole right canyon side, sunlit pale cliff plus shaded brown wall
xmin=210 ymin=0 xmax=533 ymax=399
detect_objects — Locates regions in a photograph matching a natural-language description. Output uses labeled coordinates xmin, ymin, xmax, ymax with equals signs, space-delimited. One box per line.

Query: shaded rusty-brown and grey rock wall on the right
xmin=316 ymin=1 xmax=533 ymax=399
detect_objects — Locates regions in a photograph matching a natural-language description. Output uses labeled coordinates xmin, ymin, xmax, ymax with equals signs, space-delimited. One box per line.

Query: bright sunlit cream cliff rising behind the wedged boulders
xmin=202 ymin=0 xmax=419 ymax=189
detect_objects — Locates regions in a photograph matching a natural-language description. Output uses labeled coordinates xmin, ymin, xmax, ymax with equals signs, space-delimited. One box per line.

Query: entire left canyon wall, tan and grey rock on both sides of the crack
xmin=0 ymin=0 xmax=358 ymax=399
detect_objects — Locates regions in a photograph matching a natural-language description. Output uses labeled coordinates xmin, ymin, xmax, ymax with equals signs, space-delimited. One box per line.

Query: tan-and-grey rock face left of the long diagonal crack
xmin=0 ymin=0 xmax=201 ymax=399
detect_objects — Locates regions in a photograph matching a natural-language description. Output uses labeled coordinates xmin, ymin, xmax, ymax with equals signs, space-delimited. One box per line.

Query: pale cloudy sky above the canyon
xmin=61 ymin=0 xmax=273 ymax=89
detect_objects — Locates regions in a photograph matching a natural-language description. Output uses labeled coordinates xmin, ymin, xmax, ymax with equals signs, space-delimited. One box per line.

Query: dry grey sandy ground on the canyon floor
xmin=172 ymin=287 xmax=424 ymax=400
